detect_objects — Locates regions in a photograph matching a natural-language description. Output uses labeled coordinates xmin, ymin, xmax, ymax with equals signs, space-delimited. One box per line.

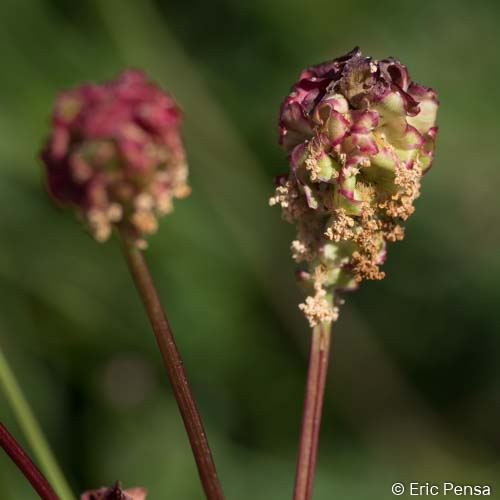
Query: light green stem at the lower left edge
xmin=0 ymin=346 xmax=75 ymax=500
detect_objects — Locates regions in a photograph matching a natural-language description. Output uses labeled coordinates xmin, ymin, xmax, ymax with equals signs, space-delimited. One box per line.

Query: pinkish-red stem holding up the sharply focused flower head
xmin=293 ymin=323 xmax=331 ymax=500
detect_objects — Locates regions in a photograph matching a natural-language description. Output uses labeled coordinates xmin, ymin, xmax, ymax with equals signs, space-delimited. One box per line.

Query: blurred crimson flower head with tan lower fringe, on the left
xmin=42 ymin=70 xmax=190 ymax=246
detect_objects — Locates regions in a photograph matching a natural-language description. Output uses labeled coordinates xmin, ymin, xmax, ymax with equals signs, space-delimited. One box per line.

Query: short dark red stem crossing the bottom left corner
xmin=0 ymin=422 xmax=58 ymax=500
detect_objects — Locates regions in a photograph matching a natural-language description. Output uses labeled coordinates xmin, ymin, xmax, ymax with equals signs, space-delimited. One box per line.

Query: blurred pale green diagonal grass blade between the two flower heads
xmin=94 ymin=0 xmax=303 ymax=332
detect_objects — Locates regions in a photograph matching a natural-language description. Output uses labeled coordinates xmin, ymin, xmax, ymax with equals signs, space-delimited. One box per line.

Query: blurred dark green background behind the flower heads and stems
xmin=0 ymin=0 xmax=500 ymax=500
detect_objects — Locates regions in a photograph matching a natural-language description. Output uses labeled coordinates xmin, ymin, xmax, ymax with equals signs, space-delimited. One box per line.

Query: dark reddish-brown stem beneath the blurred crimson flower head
xmin=119 ymin=227 xmax=224 ymax=500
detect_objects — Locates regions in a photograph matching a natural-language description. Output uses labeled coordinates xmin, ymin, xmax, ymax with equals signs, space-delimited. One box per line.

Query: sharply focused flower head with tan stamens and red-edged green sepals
xmin=270 ymin=48 xmax=438 ymax=326
